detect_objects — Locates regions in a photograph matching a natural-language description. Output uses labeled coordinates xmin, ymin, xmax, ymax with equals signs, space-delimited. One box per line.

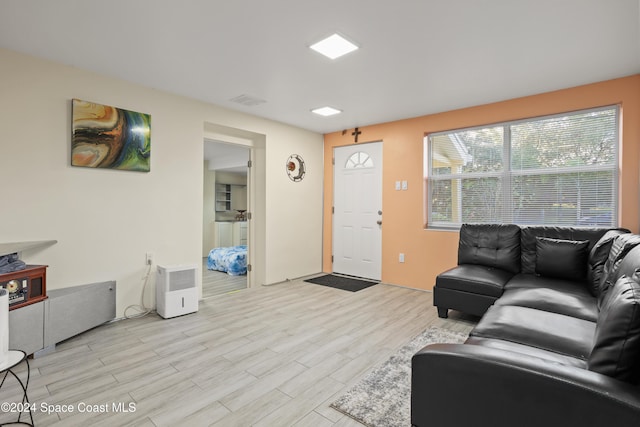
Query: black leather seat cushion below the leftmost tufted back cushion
xmin=436 ymin=264 xmax=513 ymax=297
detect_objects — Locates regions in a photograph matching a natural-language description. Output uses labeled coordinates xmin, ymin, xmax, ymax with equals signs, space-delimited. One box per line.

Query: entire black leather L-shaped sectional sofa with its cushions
xmin=411 ymin=224 xmax=640 ymax=427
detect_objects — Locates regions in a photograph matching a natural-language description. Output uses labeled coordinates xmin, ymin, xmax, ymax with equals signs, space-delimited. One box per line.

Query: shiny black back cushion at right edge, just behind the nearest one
xmin=598 ymin=234 xmax=640 ymax=308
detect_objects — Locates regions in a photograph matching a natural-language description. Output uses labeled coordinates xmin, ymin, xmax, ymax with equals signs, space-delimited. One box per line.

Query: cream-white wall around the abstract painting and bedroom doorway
xmin=0 ymin=49 xmax=323 ymax=316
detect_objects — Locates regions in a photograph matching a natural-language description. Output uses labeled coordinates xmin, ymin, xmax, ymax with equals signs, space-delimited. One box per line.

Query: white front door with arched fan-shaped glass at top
xmin=333 ymin=142 xmax=382 ymax=280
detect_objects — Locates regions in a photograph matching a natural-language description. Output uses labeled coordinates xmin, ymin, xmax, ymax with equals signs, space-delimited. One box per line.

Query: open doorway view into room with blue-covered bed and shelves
xmin=202 ymin=139 xmax=251 ymax=298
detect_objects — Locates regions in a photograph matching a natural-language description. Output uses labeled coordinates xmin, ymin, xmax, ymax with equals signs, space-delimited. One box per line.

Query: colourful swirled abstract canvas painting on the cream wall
xmin=71 ymin=99 xmax=151 ymax=172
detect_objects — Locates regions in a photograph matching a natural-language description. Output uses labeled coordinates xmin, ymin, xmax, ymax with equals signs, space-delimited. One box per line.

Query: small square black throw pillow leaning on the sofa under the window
xmin=536 ymin=237 xmax=589 ymax=281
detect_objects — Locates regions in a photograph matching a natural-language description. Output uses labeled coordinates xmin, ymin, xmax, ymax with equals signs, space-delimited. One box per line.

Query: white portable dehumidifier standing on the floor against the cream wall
xmin=156 ymin=265 xmax=198 ymax=319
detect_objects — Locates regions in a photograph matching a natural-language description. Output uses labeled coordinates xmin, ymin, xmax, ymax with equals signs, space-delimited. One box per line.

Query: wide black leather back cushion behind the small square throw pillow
xmin=520 ymin=229 xmax=610 ymax=274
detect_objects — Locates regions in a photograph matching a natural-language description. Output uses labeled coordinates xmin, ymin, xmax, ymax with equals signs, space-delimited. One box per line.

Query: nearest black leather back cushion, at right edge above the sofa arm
xmin=587 ymin=276 xmax=640 ymax=384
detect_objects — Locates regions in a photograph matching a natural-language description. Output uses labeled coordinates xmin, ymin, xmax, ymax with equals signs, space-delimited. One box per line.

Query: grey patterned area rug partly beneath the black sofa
xmin=330 ymin=327 xmax=467 ymax=427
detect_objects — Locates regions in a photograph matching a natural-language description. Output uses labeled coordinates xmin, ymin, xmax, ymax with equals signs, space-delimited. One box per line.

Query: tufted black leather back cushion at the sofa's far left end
xmin=458 ymin=224 xmax=520 ymax=273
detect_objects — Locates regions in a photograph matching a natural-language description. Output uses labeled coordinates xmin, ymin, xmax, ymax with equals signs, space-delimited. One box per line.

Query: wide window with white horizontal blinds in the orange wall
xmin=425 ymin=107 xmax=619 ymax=228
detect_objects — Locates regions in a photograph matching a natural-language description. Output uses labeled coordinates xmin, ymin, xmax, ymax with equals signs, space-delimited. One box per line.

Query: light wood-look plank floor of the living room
xmin=0 ymin=280 xmax=475 ymax=427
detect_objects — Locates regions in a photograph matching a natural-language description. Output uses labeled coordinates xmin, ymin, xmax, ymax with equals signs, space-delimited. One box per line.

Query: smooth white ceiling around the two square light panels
xmin=0 ymin=0 xmax=640 ymax=133
